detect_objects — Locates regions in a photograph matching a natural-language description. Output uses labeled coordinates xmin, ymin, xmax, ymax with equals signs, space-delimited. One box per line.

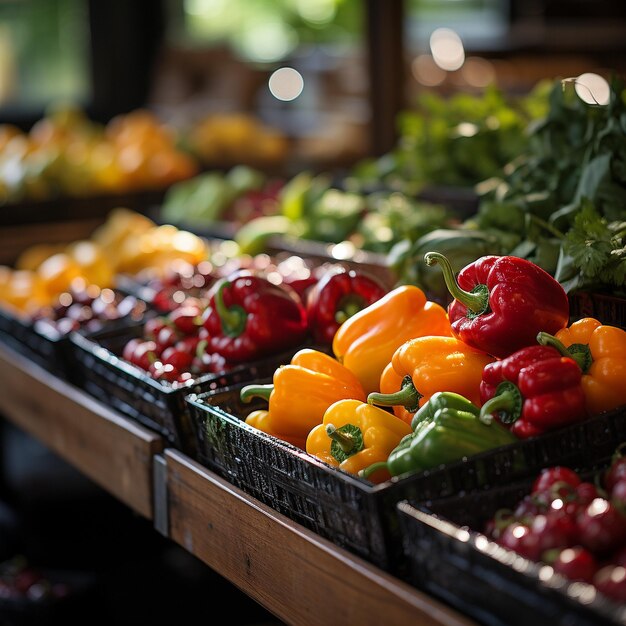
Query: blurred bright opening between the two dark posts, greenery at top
xmin=151 ymin=0 xmax=370 ymax=168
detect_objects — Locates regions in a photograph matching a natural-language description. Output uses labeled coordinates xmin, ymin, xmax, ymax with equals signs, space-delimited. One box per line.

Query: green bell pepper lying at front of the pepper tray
xmin=360 ymin=391 xmax=517 ymax=478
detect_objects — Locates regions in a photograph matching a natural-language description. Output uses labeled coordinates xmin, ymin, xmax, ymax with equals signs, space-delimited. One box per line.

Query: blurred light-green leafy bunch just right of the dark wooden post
xmin=353 ymin=84 xmax=547 ymax=193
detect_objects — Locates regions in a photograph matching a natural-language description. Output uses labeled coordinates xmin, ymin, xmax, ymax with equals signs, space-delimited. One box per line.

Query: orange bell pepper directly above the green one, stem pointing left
xmin=367 ymin=337 xmax=494 ymax=423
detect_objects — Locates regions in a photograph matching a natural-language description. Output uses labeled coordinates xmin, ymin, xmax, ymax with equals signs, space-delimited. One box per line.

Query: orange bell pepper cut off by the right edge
xmin=537 ymin=317 xmax=626 ymax=415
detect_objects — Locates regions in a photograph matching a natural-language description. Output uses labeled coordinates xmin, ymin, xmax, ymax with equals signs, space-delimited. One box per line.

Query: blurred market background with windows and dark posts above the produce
xmin=0 ymin=0 xmax=626 ymax=171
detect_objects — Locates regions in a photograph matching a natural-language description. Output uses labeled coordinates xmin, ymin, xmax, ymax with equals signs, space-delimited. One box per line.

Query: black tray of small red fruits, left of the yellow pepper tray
xmin=70 ymin=323 xmax=304 ymax=459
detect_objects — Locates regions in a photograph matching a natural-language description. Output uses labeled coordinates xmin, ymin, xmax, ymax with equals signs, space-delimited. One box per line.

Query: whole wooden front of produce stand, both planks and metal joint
xmin=0 ymin=344 xmax=475 ymax=626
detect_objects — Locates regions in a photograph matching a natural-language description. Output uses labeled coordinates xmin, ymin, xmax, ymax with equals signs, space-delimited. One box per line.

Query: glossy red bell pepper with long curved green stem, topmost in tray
xmin=424 ymin=252 xmax=569 ymax=358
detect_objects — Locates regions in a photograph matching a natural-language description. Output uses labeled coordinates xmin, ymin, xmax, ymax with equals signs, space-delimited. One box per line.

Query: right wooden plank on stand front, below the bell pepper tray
xmin=165 ymin=449 xmax=474 ymax=626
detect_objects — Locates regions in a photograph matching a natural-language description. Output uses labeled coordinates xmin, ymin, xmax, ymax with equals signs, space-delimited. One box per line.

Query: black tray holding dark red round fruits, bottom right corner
xmin=397 ymin=457 xmax=626 ymax=626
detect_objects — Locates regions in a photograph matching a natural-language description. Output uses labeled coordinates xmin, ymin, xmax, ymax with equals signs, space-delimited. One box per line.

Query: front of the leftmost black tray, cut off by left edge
xmin=0 ymin=308 xmax=72 ymax=380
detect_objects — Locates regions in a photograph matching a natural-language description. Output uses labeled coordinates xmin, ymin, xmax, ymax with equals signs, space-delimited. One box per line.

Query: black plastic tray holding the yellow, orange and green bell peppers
xmin=186 ymin=388 xmax=626 ymax=576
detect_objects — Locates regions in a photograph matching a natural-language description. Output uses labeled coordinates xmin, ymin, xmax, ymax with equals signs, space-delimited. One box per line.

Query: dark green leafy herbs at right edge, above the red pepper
xmin=472 ymin=80 xmax=626 ymax=291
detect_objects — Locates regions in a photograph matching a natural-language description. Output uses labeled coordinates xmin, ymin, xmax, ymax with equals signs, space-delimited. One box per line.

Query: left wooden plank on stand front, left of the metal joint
xmin=0 ymin=345 xmax=163 ymax=519
